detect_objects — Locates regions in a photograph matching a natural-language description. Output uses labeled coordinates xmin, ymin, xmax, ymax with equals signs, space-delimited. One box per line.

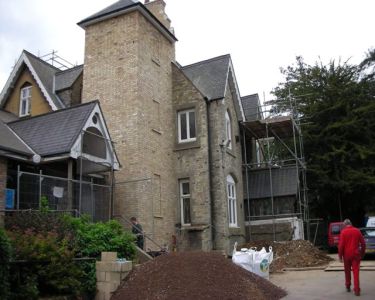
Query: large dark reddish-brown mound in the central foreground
xmin=111 ymin=252 xmax=286 ymax=300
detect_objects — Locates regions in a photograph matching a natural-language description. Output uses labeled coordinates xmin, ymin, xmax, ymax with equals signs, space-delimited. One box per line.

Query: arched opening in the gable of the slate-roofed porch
xmin=82 ymin=127 xmax=107 ymax=159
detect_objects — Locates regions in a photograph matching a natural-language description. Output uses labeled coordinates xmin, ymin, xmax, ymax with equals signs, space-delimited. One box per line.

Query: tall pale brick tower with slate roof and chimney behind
xmin=78 ymin=0 xmax=177 ymax=248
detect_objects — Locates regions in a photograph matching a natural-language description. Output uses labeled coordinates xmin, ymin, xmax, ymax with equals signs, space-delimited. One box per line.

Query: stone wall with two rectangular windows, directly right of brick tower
xmin=172 ymin=66 xmax=212 ymax=251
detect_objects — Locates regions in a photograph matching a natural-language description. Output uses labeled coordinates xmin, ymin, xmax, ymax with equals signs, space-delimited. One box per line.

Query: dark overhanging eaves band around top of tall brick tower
xmin=77 ymin=2 xmax=178 ymax=42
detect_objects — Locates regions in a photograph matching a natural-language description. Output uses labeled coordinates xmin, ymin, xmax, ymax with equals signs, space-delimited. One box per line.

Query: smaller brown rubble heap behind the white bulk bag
xmin=237 ymin=240 xmax=332 ymax=272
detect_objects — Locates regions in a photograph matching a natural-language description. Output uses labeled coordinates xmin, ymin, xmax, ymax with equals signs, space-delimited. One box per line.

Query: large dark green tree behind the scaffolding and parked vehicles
xmin=271 ymin=51 xmax=375 ymax=224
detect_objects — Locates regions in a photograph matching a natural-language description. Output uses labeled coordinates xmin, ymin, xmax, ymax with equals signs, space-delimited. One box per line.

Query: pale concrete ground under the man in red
xmin=270 ymin=255 xmax=375 ymax=300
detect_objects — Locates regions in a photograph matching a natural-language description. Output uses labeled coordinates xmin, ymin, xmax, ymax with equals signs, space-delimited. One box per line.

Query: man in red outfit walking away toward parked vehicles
xmin=339 ymin=219 xmax=366 ymax=296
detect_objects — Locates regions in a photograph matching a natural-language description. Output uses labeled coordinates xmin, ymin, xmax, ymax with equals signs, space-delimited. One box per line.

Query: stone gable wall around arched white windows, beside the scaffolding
xmin=209 ymin=85 xmax=245 ymax=253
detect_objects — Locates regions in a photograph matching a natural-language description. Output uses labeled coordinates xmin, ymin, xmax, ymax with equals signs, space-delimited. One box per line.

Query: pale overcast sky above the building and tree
xmin=0 ymin=0 xmax=375 ymax=100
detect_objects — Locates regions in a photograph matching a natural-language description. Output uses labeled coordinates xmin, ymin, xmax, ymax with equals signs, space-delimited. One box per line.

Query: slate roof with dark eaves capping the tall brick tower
xmin=77 ymin=0 xmax=177 ymax=42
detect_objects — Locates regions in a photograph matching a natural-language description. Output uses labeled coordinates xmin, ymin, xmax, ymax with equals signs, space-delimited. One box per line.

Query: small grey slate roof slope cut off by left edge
xmin=0 ymin=121 xmax=35 ymax=156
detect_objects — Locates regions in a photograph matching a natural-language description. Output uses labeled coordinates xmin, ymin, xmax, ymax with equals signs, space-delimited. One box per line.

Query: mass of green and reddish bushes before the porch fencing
xmin=4 ymin=210 xmax=135 ymax=299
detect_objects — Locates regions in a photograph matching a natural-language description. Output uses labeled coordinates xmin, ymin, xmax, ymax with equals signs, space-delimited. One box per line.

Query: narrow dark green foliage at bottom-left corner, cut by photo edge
xmin=0 ymin=228 xmax=12 ymax=299
